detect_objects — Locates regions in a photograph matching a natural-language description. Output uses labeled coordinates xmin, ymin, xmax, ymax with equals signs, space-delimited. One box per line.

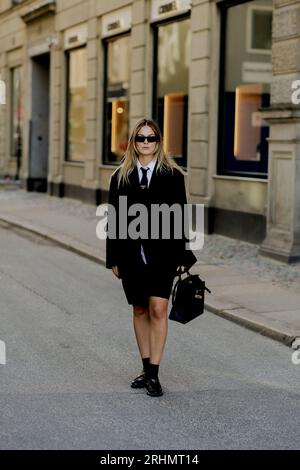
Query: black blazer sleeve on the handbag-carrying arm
xmin=174 ymin=170 xmax=197 ymax=269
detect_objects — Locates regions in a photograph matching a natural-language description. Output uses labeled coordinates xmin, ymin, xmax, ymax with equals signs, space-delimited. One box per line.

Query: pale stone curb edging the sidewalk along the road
xmin=0 ymin=216 xmax=298 ymax=347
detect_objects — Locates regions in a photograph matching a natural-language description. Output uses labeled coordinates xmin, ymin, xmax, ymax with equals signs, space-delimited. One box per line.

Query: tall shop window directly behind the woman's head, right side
xmin=153 ymin=18 xmax=191 ymax=167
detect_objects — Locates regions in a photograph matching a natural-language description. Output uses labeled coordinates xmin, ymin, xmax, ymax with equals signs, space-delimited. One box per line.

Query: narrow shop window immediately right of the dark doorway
xmin=67 ymin=47 xmax=87 ymax=161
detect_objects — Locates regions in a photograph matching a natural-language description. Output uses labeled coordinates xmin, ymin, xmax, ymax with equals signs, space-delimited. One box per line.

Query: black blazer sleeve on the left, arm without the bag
xmin=106 ymin=174 xmax=119 ymax=269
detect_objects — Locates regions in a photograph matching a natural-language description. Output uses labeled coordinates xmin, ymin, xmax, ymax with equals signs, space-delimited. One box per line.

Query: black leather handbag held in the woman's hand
xmin=169 ymin=271 xmax=211 ymax=324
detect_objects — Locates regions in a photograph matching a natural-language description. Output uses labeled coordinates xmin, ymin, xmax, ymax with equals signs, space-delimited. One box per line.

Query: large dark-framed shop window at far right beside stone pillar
xmin=218 ymin=0 xmax=272 ymax=178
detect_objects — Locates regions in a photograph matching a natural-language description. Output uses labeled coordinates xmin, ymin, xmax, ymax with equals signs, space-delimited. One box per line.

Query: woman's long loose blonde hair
xmin=113 ymin=118 xmax=182 ymax=187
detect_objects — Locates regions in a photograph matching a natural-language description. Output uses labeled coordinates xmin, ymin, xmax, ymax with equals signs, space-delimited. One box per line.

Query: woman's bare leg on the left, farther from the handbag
xmin=133 ymin=305 xmax=150 ymax=358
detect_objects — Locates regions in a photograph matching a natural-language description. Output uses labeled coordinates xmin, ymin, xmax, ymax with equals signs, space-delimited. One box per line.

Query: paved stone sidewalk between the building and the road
xmin=0 ymin=187 xmax=300 ymax=346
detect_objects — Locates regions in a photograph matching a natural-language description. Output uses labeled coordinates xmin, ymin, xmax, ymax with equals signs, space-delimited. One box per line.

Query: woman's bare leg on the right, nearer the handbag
xmin=149 ymin=296 xmax=169 ymax=364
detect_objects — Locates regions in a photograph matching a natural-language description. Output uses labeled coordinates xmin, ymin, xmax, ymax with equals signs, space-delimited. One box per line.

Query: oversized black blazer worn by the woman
xmin=106 ymin=162 xmax=197 ymax=278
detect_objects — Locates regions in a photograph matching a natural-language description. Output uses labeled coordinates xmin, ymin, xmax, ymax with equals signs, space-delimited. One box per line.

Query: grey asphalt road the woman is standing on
xmin=0 ymin=228 xmax=300 ymax=450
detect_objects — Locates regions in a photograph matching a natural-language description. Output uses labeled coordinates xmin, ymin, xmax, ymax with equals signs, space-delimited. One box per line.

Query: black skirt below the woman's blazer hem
xmin=122 ymin=259 xmax=176 ymax=307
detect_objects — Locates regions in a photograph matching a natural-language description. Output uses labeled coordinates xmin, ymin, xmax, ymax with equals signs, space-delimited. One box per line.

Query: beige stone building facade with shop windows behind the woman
xmin=0 ymin=0 xmax=300 ymax=261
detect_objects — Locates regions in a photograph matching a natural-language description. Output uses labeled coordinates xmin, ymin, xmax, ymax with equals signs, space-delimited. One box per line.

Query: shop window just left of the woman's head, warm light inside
xmin=103 ymin=35 xmax=130 ymax=163
